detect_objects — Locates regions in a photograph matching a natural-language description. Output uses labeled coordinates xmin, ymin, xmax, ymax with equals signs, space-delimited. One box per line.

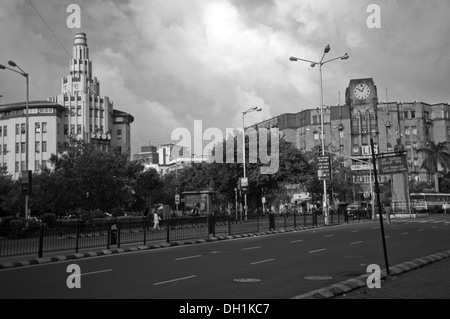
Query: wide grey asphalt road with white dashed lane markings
xmin=0 ymin=215 xmax=450 ymax=300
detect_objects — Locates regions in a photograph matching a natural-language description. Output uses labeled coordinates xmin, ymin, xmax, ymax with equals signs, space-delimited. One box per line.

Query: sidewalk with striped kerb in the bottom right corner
xmin=292 ymin=250 xmax=450 ymax=299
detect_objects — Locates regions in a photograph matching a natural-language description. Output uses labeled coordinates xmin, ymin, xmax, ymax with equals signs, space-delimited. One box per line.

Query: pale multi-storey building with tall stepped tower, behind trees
xmin=0 ymin=33 xmax=134 ymax=178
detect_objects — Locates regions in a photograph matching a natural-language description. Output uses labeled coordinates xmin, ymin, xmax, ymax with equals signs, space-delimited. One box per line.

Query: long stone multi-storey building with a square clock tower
xmin=253 ymin=78 xmax=450 ymax=201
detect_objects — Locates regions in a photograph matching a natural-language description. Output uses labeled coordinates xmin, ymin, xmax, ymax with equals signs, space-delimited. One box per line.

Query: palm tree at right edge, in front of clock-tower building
xmin=417 ymin=141 xmax=450 ymax=193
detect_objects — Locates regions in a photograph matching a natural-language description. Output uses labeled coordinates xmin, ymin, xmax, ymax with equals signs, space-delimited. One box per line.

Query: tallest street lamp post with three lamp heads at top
xmin=289 ymin=44 xmax=349 ymax=225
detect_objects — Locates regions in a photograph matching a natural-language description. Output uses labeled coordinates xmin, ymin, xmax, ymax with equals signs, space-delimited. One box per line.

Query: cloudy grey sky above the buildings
xmin=0 ymin=0 xmax=450 ymax=158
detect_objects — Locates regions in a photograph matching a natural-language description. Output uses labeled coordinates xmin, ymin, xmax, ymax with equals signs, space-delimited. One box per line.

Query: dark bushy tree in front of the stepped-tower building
xmin=50 ymin=138 xmax=144 ymax=212
